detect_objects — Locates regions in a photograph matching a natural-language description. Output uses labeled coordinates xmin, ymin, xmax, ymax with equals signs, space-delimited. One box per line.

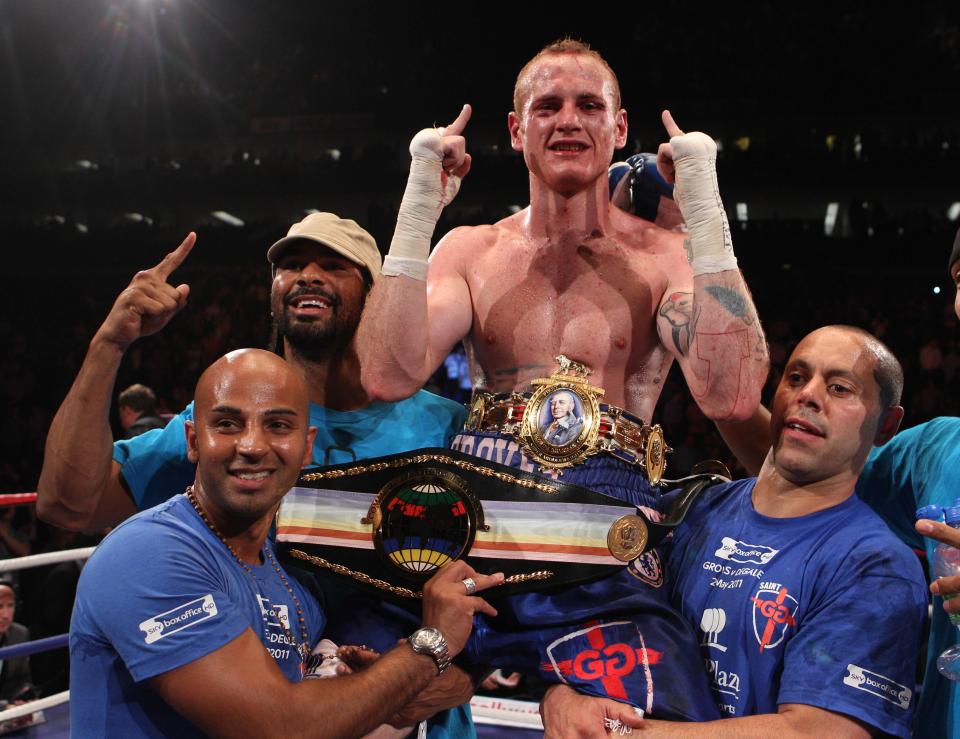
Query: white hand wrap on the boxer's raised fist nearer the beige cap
xmin=381 ymin=128 xmax=460 ymax=280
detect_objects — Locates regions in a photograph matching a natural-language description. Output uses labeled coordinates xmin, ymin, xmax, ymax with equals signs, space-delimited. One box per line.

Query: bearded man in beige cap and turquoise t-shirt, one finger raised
xmin=37 ymin=213 xmax=472 ymax=737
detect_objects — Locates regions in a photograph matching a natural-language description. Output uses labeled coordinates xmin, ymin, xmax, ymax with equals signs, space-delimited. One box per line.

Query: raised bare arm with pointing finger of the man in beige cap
xmin=37 ymin=233 xmax=196 ymax=530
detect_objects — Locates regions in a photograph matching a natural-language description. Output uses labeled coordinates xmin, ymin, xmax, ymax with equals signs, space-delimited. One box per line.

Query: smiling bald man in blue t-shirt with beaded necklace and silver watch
xmin=70 ymin=349 xmax=503 ymax=736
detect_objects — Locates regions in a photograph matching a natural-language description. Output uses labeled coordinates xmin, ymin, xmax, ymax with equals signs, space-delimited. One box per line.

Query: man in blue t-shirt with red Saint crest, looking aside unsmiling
xmin=545 ymin=326 xmax=926 ymax=736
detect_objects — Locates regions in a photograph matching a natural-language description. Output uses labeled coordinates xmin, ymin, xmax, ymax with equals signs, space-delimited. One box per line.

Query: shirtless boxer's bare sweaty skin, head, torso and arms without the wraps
xmin=358 ymin=54 xmax=767 ymax=420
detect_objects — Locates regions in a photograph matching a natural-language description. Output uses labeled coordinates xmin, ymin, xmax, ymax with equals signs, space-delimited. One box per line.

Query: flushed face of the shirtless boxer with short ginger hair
xmin=508 ymin=54 xmax=627 ymax=194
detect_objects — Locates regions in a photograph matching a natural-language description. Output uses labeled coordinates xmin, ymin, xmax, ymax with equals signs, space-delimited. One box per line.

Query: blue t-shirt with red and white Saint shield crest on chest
xmin=669 ymin=479 xmax=927 ymax=737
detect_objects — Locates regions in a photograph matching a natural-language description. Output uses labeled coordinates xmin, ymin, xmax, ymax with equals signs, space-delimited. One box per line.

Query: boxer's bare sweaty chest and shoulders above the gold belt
xmin=431 ymin=211 xmax=693 ymax=420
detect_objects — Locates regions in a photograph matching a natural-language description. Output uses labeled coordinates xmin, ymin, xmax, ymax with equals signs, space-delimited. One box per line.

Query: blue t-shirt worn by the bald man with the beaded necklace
xmin=70 ymin=495 xmax=325 ymax=737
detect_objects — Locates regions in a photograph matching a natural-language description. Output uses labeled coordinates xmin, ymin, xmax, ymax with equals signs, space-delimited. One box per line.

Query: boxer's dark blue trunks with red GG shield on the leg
xmin=451 ymin=431 xmax=719 ymax=721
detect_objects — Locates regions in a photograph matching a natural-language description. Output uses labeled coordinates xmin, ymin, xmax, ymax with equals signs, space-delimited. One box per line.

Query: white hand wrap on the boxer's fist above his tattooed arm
xmin=670 ymin=131 xmax=737 ymax=276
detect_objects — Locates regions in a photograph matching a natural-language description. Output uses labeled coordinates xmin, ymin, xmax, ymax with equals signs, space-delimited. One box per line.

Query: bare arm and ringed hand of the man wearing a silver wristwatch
xmin=150 ymin=561 xmax=503 ymax=737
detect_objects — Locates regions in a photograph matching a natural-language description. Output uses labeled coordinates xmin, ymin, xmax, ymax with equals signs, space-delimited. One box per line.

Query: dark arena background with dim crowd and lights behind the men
xmin=0 ymin=0 xmax=960 ymax=736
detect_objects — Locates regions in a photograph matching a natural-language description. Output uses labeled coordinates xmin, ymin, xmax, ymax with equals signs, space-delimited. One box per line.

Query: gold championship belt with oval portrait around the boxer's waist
xmin=464 ymin=354 xmax=673 ymax=485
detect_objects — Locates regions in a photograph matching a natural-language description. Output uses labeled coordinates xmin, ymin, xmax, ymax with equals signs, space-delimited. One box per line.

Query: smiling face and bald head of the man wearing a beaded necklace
xmin=187 ymin=349 xmax=316 ymax=528
